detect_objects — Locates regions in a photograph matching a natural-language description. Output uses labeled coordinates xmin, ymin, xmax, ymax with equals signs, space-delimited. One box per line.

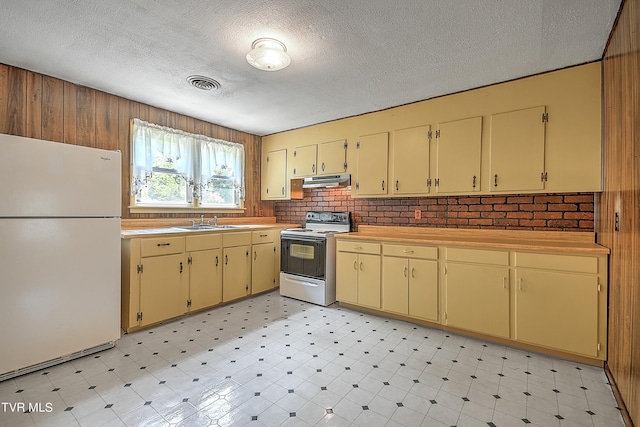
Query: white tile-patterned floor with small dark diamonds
xmin=0 ymin=292 xmax=624 ymax=427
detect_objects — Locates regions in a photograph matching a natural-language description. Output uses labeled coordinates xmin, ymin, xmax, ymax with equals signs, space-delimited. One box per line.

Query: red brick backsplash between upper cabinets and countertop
xmin=275 ymin=187 xmax=594 ymax=231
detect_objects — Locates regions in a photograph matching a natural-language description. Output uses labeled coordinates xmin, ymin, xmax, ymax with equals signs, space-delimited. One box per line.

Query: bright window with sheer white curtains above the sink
xmin=131 ymin=119 xmax=244 ymax=208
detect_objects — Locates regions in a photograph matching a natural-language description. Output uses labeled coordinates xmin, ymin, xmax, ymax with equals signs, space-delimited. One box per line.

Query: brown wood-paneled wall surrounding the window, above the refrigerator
xmin=0 ymin=64 xmax=274 ymax=219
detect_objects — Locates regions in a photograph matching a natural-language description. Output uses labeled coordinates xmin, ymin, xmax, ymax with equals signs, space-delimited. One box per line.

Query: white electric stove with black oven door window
xmin=280 ymin=212 xmax=351 ymax=306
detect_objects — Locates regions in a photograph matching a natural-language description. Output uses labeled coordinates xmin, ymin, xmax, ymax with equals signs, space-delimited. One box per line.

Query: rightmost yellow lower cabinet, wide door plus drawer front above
xmin=514 ymin=252 xmax=606 ymax=357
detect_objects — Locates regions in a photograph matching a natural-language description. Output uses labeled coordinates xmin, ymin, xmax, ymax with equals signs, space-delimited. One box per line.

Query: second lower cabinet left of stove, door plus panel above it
xmin=222 ymin=231 xmax=251 ymax=302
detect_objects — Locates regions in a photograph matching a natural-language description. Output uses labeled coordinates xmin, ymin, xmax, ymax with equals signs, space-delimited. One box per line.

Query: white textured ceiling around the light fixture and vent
xmin=0 ymin=0 xmax=621 ymax=135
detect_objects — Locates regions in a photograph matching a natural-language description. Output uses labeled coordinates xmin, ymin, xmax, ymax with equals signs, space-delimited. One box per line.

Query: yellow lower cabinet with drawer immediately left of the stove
xmin=251 ymin=230 xmax=280 ymax=294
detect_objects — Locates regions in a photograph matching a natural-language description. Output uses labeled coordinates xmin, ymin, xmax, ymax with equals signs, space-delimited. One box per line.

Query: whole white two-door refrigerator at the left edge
xmin=0 ymin=134 xmax=122 ymax=381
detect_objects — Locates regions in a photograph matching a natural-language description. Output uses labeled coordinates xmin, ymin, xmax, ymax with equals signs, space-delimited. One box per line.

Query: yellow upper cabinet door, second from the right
xmin=434 ymin=117 xmax=482 ymax=193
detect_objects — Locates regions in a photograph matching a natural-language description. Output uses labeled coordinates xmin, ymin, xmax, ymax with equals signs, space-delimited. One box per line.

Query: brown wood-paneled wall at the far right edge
xmin=596 ymin=0 xmax=640 ymax=425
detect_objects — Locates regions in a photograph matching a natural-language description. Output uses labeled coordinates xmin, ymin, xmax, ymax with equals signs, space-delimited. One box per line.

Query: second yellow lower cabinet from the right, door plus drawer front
xmin=443 ymin=248 xmax=510 ymax=338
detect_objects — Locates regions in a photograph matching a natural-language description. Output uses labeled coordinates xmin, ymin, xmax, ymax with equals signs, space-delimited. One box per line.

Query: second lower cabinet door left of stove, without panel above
xmin=222 ymin=246 xmax=251 ymax=302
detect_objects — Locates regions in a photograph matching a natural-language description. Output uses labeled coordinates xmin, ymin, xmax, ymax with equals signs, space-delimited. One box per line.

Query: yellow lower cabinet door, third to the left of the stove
xmin=189 ymin=249 xmax=222 ymax=310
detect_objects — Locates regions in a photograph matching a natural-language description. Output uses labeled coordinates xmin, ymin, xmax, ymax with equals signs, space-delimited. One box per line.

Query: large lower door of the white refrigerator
xmin=0 ymin=218 xmax=120 ymax=374
